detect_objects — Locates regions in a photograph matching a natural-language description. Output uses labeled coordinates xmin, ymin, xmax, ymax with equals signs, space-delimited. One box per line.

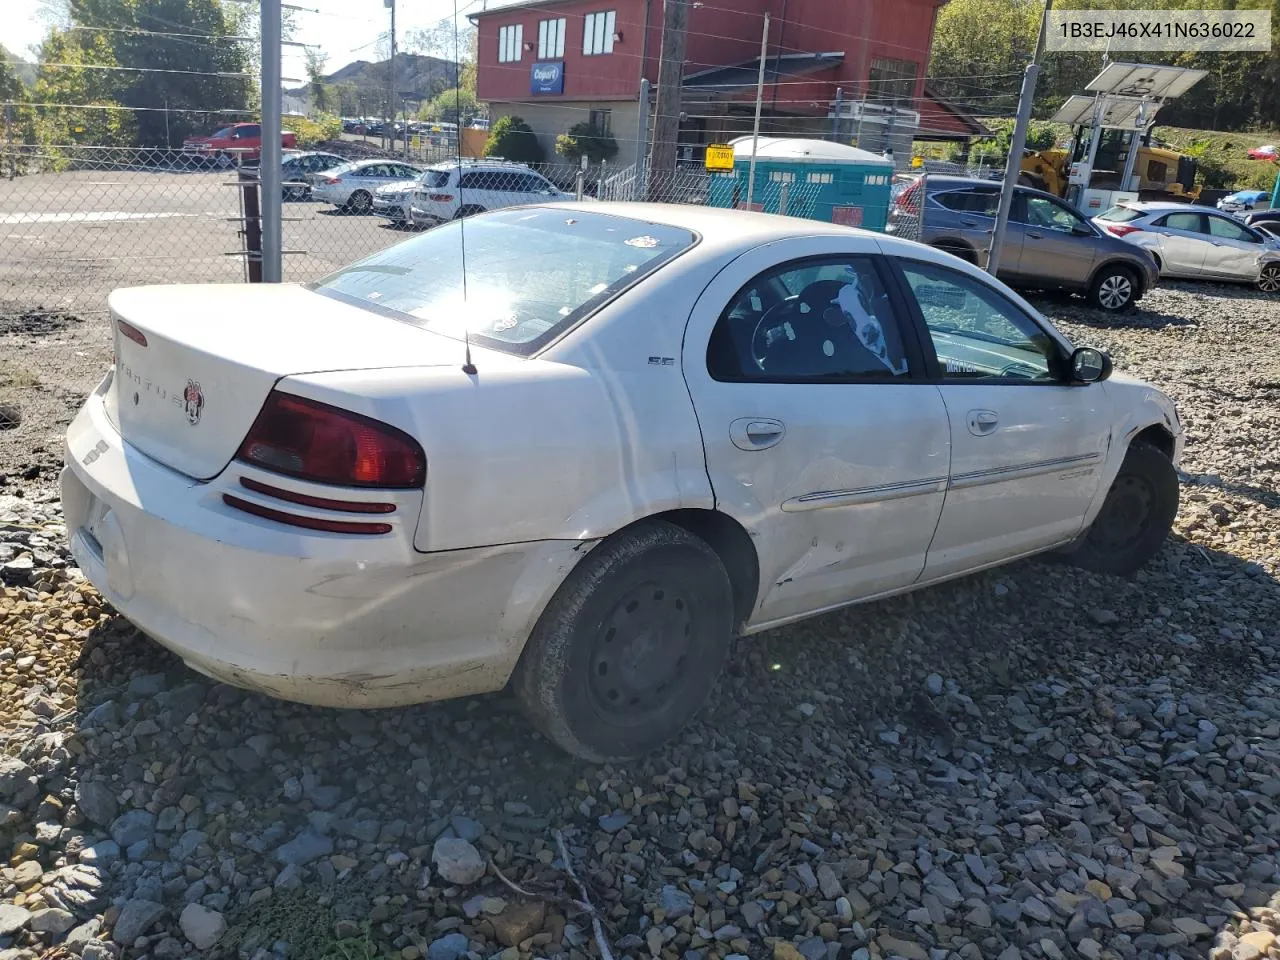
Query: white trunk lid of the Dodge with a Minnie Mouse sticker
xmin=106 ymin=284 xmax=462 ymax=480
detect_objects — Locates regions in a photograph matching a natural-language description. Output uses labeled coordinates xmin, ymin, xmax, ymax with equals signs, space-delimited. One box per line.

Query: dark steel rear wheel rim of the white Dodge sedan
xmin=588 ymin=582 xmax=694 ymax=724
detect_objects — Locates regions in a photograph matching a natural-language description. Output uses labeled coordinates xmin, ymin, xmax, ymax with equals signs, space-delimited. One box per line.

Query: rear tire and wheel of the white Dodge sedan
xmin=513 ymin=521 xmax=733 ymax=762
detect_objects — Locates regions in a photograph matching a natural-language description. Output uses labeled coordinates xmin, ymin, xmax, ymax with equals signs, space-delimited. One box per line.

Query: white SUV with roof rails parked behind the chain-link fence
xmin=411 ymin=160 xmax=573 ymax=227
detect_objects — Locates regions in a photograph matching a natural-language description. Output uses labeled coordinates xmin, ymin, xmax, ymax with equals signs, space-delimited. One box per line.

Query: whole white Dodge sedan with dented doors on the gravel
xmin=63 ymin=204 xmax=1183 ymax=759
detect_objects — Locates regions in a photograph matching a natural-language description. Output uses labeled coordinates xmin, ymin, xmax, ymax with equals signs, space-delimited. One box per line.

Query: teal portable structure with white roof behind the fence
xmin=708 ymin=137 xmax=893 ymax=230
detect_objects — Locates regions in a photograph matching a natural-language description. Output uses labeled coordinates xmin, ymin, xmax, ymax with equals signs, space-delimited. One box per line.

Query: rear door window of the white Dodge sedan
xmin=707 ymin=257 xmax=910 ymax=383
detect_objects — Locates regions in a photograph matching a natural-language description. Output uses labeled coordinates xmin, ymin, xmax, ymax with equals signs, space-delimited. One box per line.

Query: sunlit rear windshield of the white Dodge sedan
xmin=311 ymin=207 xmax=698 ymax=356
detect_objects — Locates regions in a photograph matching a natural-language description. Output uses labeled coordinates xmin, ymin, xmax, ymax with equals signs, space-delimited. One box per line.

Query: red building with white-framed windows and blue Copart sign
xmin=472 ymin=0 xmax=983 ymax=166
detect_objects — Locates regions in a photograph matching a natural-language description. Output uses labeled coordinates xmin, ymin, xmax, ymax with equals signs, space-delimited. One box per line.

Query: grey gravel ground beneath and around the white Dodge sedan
xmin=0 ymin=284 xmax=1280 ymax=960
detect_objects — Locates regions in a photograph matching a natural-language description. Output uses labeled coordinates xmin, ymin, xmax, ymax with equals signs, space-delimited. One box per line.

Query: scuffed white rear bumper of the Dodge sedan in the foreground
xmin=63 ymin=393 xmax=590 ymax=708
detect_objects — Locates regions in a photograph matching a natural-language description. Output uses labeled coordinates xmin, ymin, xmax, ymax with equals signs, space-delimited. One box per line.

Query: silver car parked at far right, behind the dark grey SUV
xmin=1093 ymin=202 xmax=1280 ymax=293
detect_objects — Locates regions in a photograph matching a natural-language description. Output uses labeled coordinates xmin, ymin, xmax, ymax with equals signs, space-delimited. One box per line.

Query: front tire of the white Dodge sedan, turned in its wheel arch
xmin=1066 ymin=440 xmax=1178 ymax=576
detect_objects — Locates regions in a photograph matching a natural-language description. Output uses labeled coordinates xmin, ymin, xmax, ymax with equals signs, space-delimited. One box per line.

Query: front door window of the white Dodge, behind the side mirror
xmin=901 ymin=261 xmax=1059 ymax=383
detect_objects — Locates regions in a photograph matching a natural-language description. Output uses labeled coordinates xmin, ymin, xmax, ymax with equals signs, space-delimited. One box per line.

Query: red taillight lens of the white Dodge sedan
xmin=236 ymin=390 xmax=426 ymax=489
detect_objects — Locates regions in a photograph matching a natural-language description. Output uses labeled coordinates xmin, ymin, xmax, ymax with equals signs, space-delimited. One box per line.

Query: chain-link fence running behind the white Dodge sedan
xmin=0 ymin=138 xmax=919 ymax=475
